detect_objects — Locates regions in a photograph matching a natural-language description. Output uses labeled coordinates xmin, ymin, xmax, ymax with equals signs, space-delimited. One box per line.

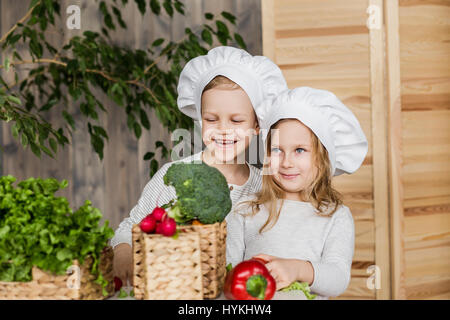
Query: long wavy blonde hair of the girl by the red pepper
xmin=239 ymin=119 xmax=342 ymax=233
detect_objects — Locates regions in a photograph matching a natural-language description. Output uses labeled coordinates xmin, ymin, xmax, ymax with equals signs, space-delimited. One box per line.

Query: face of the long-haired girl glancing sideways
xmin=269 ymin=119 xmax=317 ymax=201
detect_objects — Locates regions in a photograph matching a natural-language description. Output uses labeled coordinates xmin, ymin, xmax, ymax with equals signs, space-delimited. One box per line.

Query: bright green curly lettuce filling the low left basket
xmin=0 ymin=175 xmax=114 ymax=295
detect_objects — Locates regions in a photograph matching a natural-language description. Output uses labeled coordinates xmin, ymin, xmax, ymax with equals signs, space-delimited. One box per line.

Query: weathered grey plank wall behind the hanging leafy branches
xmin=0 ymin=0 xmax=262 ymax=228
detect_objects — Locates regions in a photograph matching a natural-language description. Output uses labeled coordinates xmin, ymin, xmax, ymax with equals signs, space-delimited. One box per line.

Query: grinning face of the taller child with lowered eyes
xmin=202 ymin=87 xmax=259 ymax=163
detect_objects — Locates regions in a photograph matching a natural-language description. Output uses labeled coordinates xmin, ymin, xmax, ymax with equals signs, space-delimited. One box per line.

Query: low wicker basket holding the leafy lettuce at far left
xmin=0 ymin=247 xmax=114 ymax=300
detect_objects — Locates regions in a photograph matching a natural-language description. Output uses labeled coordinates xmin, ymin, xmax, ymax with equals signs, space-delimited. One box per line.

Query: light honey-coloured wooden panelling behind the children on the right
xmin=262 ymin=0 xmax=450 ymax=299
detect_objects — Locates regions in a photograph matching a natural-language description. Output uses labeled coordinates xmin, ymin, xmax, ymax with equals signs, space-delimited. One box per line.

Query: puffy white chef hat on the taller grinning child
xmin=177 ymin=46 xmax=287 ymax=125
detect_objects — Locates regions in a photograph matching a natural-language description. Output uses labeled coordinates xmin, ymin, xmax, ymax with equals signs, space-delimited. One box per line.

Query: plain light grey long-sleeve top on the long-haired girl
xmin=226 ymin=198 xmax=355 ymax=299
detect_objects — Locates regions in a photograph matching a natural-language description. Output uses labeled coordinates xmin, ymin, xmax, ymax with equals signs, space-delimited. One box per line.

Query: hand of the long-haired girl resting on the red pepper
xmin=253 ymin=254 xmax=312 ymax=290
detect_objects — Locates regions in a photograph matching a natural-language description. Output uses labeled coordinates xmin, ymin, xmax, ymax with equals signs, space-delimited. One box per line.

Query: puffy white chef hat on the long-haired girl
xmin=260 ymin=87 xmax=368 ymax=176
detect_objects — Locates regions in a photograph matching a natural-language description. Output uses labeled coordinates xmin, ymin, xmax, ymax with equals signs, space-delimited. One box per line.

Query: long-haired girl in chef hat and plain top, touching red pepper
xmin=226 ymin=87 xmax=368 ymax=299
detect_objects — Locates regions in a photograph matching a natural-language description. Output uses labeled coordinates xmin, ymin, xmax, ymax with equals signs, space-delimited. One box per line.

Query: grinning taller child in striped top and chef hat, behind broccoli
xmin=111 ymin=46 xmax=287 ymax=285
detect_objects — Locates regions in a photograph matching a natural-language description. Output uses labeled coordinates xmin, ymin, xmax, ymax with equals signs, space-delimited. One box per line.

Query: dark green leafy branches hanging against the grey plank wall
xmin=0 ymin=0 xmax=246 ymax=176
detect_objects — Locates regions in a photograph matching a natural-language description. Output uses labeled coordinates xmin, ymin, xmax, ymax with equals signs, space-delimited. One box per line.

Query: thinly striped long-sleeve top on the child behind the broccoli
xmin=110 ymin=152 xmax=262 ymax=248
